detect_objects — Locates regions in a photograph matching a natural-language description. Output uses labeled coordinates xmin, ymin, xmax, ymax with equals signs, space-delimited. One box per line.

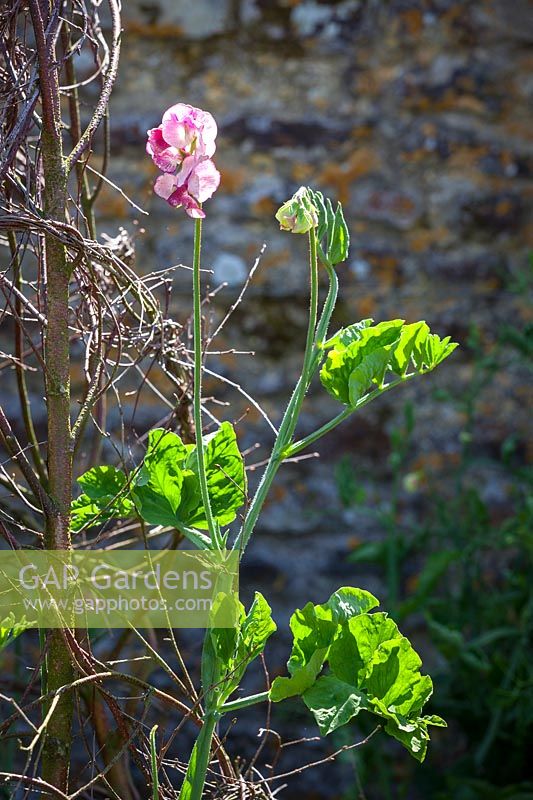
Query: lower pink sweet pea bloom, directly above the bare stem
xmin=154 ymin=156 xmax=220 ymax=218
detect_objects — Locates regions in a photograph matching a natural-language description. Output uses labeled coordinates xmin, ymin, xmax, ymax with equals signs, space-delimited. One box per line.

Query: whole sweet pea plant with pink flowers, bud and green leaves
xmin=72 ymin=103 xmax=457 ymax=800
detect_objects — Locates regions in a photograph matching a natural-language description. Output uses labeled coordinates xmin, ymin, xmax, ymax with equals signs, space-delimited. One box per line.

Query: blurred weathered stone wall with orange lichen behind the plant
xmin=92 ymin=0 xmax=533 ymax=798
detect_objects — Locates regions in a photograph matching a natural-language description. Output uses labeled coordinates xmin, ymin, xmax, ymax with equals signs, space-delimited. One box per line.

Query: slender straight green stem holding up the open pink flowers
xmin=193 ymin=219 xmax=218 ymax=546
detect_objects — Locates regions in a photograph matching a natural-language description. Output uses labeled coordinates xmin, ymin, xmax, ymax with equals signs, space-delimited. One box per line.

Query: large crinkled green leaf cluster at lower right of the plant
xmin=270 ymin=587 xmax=446 ymax=760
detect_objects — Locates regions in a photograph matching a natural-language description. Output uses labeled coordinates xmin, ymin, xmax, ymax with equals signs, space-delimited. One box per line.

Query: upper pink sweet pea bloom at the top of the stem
xmin=146 ymin=103 xmax=217 ymax=172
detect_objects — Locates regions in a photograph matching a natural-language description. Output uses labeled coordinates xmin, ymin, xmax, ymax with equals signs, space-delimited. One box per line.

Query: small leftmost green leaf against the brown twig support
xmin=71 ymin=466 xmax=135 ymax=531
